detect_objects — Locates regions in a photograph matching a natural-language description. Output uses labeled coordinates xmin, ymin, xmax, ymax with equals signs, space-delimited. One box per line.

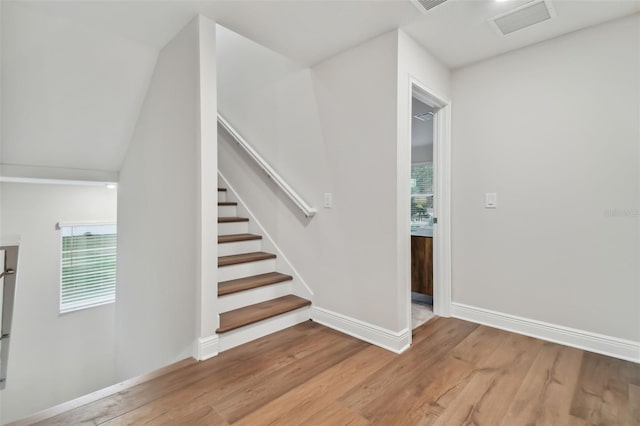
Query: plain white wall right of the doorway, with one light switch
xmin=452 ymin=15 xmax=640 ymax=342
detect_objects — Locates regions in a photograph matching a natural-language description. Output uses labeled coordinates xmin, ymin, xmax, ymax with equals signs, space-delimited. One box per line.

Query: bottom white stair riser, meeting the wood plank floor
xmin=219 ymin=306 xmax=311 ymax=352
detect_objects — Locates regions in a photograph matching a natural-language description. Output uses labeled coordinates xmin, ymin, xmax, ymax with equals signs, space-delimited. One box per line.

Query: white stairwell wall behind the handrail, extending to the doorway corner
xmin=218 ymin=30 xmax=408 ymax=332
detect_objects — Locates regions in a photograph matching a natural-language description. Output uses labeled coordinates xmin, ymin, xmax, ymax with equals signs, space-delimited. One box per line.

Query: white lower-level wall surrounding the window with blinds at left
xmin=0 ymin=183 xmax=117 ymax=423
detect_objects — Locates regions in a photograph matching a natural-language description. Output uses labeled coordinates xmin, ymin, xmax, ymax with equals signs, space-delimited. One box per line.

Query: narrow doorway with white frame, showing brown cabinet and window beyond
xmin=405 ymin=79 xmax=451 ymax=328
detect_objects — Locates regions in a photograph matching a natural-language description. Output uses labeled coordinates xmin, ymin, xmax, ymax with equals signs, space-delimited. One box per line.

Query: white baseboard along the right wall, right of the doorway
xmin=451 ymin=303 xmax=640 ymax=363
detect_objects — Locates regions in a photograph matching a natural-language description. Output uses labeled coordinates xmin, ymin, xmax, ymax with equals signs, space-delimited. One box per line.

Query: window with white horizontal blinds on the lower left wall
xmin=60 ymin=224 xmax=116 ymax=313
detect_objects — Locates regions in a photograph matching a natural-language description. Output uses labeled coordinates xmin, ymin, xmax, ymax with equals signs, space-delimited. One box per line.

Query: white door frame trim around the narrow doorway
xmin=408 ymin=76 xmax=451 ymax=329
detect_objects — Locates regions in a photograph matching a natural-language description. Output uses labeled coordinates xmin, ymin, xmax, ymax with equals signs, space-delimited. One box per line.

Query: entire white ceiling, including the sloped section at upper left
xmin=0 ymin=0 xmax=640 ymax=171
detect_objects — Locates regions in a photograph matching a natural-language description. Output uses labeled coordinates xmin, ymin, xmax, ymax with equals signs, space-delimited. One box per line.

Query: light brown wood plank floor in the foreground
xmin=17 ymin=318 xmax=640 ymax=426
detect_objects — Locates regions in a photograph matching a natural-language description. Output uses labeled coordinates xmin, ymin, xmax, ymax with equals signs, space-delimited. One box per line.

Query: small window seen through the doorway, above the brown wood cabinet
xmin=411 ymin=163 xmax=433 ymax=230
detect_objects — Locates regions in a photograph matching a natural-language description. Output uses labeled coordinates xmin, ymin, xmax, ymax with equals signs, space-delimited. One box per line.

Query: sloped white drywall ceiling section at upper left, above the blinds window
xmin=1 ymin=1 xmax=158 ymax=174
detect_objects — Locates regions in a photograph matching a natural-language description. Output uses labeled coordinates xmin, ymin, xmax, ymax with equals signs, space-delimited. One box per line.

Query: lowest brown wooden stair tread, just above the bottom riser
xmin=216 ymin=294 xmax=311 ymax=333
